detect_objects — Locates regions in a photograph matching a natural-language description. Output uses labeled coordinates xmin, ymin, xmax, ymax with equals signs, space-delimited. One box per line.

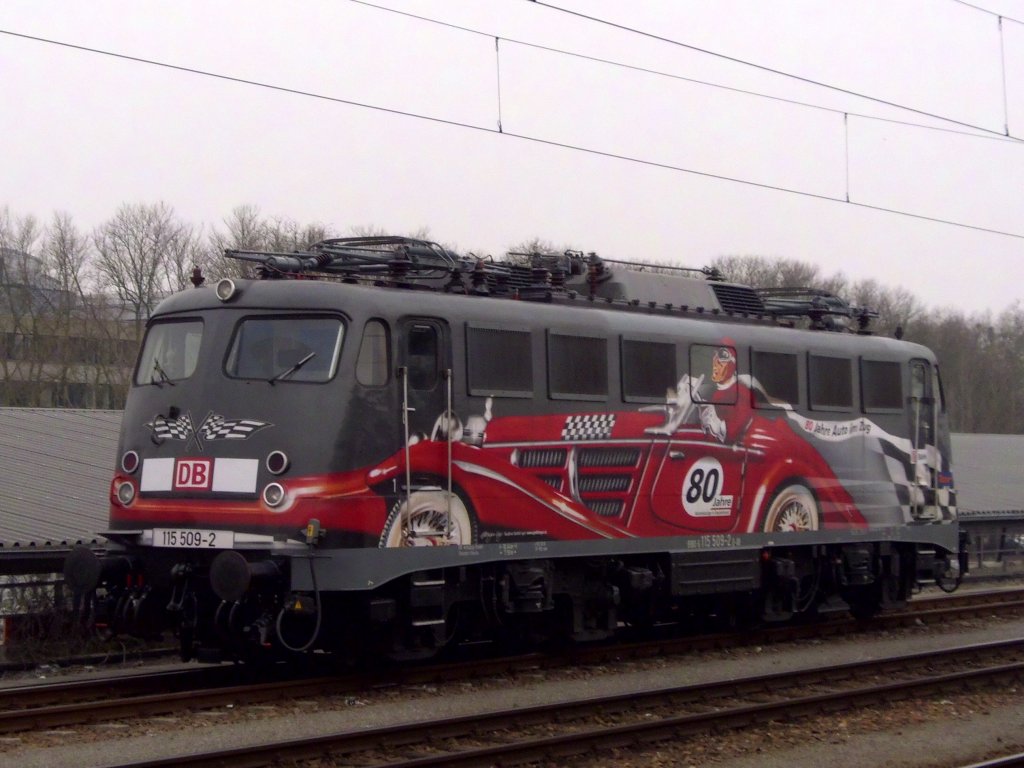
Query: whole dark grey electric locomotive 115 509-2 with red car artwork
xmin=66 ymin=238 xmax=967 ymax=659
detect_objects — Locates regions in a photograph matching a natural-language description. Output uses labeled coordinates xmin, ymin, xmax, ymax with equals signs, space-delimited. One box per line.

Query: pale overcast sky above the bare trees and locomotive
xmin=0 ymin=0 xmax=1024 ymax=312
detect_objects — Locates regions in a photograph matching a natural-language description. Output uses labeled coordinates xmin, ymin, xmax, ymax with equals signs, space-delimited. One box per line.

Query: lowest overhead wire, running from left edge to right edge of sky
xmin=0 ymin=29 xmax=1024 ymax=240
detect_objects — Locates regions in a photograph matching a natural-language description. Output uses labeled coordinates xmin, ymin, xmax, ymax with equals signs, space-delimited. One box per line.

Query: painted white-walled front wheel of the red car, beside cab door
xmin=380 ymin=488 xmax=477 ymax=548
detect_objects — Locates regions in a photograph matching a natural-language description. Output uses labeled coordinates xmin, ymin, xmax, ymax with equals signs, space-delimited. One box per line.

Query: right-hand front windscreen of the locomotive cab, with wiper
xmin=225 ymin=316 xmax=344 ymax=383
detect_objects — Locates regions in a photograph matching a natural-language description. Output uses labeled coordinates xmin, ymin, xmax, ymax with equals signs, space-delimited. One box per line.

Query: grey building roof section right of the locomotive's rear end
xmin=952 ymin=433 xmax=1024 ymax=512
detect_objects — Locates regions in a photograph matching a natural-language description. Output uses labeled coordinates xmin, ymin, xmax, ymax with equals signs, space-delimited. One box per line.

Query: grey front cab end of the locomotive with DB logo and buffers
xmin=68 ymin=281 xmax=407 ymax=655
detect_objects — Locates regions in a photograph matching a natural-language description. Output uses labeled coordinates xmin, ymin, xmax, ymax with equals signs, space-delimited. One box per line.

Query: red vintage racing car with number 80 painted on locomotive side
xmin=368 ymin=376 xmax=866 ymax=546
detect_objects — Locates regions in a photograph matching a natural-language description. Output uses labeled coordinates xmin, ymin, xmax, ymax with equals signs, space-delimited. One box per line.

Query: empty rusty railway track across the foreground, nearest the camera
xmin=86 ymin=640 xmax=1024 ymax=768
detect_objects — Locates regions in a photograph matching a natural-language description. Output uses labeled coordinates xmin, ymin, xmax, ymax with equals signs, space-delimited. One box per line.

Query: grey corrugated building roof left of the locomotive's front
xmin=0 ymin=408 xmax=121 ymax=554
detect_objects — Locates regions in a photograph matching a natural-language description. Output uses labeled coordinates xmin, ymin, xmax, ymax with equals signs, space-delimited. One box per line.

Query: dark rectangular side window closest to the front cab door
xmin=466 ymin=326 xmax=534 ymax=397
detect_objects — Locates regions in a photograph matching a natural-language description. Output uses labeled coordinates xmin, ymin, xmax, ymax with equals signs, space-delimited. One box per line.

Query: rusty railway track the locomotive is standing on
xmin=0 ymin=590 xmax=1024 ymax=734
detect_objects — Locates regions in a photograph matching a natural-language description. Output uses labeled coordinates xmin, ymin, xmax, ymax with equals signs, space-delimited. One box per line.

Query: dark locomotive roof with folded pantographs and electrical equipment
xmin=148 ymin=237 xmax=917 ymax=350
